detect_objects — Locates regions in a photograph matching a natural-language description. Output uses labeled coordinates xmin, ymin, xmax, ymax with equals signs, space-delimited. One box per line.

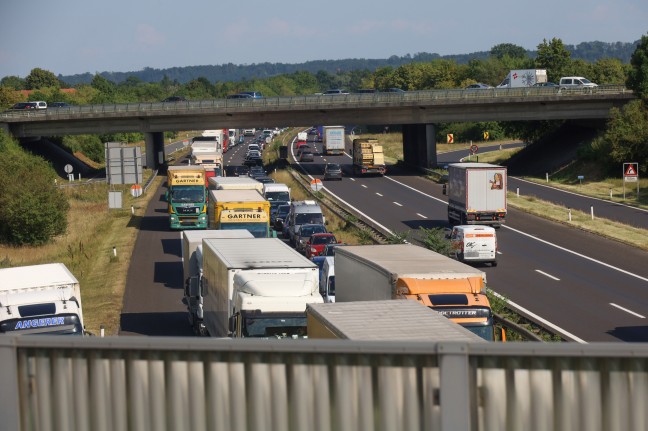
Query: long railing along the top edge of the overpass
xmin=0 ymin=85 xmax=631 ymax=120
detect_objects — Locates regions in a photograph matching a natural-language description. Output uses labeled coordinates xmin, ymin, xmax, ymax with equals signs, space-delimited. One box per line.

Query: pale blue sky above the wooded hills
xmin=0 ymin=0 xmax=648 ymax=78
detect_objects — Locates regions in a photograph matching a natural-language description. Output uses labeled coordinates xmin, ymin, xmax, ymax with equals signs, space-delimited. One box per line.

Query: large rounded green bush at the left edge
xmin=0 ymin=130 xmax=69 ymax=245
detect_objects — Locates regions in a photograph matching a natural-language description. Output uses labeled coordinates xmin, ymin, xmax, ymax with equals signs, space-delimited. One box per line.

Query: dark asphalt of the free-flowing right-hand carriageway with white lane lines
xmin=302 ymin=133 xmax=648 ymax=342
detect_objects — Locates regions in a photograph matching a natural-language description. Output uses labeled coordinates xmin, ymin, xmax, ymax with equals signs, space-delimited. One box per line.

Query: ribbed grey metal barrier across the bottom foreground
xmin=0 ymin=335 xmax=648 ymax=431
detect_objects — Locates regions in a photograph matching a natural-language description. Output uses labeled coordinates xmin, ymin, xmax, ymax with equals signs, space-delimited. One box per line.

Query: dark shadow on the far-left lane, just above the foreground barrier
xmin=119 ymin=311 xmax=195 ymax=337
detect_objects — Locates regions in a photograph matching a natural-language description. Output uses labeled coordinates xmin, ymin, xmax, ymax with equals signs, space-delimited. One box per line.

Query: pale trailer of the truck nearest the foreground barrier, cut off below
xmin=306 ymin=300 xmax=486 ymax=343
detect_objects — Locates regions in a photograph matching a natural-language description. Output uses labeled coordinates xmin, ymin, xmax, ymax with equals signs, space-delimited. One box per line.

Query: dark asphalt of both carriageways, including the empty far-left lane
xmin=120 ymin=130 xmax=648 ymax=342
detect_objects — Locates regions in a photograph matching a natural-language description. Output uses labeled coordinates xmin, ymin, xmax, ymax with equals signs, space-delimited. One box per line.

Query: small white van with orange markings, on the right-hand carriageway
xmin=450 ymin=225 xmax=497 ymax=266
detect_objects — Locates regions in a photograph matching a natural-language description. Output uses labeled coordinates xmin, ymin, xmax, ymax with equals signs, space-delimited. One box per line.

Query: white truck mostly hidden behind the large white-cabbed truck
xmin=181 ymin=229 xmax=254 ymax=335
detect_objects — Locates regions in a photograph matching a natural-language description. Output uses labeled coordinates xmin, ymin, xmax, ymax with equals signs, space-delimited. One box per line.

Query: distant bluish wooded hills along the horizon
xmin=58 ymin=40 xmax=639 ymax=86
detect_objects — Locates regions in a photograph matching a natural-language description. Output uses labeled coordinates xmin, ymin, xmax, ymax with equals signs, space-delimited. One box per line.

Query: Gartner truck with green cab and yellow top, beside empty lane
xmin=165 ymin=165 xmax=207 ymax=229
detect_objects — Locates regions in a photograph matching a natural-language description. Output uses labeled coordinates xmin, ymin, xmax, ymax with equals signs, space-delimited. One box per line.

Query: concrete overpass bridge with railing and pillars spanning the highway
xmin=0 ymin=86 xmax=635 ymax=167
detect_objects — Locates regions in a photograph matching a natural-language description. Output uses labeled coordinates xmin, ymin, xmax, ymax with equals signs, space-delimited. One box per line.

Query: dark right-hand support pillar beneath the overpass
xmin=403 ymin=124 xmax=437 ymax=168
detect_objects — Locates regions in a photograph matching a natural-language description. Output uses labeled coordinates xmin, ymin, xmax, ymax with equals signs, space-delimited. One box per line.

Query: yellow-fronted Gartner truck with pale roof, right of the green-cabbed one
xmin=207 ymin=190 xmax=276 ymax=238
